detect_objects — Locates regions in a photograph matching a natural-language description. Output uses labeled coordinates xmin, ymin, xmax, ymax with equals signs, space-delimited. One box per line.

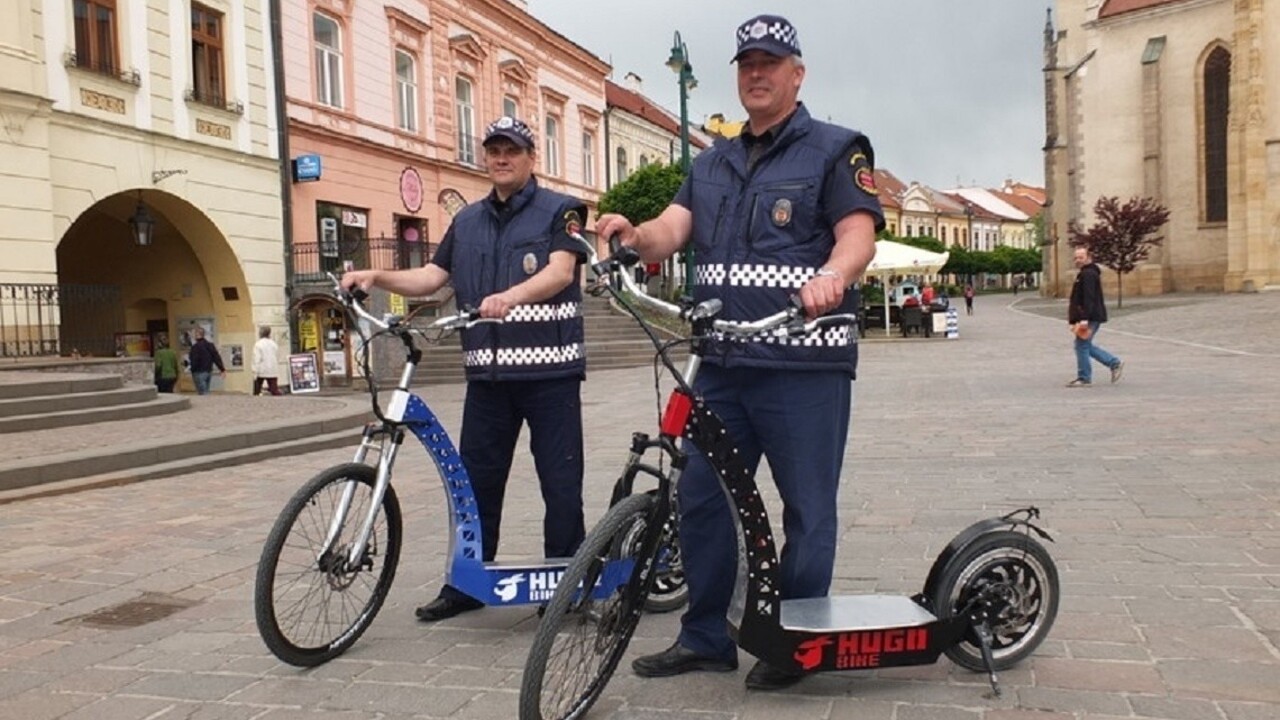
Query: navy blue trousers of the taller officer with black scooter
xmin=678 ymin=365 xmax=852 ymax=660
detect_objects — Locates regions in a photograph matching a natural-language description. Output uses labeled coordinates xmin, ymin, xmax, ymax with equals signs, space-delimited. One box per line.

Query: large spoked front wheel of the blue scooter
xmin=253 ymin=464 xmax=401 ymax=667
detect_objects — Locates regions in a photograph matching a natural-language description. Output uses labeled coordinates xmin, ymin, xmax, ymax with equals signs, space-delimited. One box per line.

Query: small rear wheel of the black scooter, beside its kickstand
xmin=933 ymin=530 xmax=1059 ymax=673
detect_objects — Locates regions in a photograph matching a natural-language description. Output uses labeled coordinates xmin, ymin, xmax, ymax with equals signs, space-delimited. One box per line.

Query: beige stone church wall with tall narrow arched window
xmin=1044 ymin=0 xmax=1280 ymax=296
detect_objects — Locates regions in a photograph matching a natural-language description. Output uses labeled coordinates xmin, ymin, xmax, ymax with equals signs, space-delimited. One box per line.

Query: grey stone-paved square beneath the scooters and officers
xmin=0 ymin=292 xmax=1280 ymax=720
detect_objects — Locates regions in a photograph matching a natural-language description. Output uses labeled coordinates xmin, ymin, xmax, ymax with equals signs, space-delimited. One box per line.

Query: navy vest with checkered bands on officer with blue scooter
xmin=451 ymin=179 xmax=586 ymax=380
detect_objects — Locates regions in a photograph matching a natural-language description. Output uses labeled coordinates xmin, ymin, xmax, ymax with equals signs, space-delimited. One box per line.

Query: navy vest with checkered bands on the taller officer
xmin=689 ymin=106 xmax=860 ymax=375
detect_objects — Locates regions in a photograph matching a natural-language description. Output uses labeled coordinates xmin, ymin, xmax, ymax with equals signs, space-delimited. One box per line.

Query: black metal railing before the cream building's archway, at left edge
xmin=0 ymin=283 xmax=124 ymax=357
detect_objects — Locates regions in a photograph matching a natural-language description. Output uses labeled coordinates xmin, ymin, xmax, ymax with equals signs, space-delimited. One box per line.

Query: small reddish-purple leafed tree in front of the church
xmin=1068 ymin=195 xmax=1169 ymax=307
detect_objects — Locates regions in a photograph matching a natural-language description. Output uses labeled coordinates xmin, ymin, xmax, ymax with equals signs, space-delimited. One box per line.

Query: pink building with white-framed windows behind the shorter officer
xmin=283 ymin=0 xmax=609 ymax=384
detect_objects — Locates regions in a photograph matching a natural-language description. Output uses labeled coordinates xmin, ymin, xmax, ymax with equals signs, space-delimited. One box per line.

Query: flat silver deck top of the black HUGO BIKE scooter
xmin=781 ymin=594 xmax=937 ymax=633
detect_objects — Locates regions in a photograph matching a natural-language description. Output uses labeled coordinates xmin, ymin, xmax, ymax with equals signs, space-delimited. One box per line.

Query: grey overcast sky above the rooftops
xmin=529 ymin=0 xmax=1048 ymax=190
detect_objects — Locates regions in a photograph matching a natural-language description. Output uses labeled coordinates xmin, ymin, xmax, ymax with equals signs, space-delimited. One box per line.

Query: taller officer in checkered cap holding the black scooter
xmin=595 ymin=15 xmax=884 ymax=689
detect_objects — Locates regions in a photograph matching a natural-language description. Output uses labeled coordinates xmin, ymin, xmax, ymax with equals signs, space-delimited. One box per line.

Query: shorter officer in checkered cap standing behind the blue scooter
xmin=342 ymin=117 xmax=586 ymax=621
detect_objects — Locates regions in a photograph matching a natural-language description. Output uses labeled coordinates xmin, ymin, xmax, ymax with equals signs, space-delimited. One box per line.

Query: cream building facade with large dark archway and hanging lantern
xmin=0 ymin=0 xmax=288 ymax=391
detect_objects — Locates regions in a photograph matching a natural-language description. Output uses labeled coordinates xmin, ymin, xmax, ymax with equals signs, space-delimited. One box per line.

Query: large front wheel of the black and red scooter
xmin=520 ymin=495 xmax=657 ymax=720
